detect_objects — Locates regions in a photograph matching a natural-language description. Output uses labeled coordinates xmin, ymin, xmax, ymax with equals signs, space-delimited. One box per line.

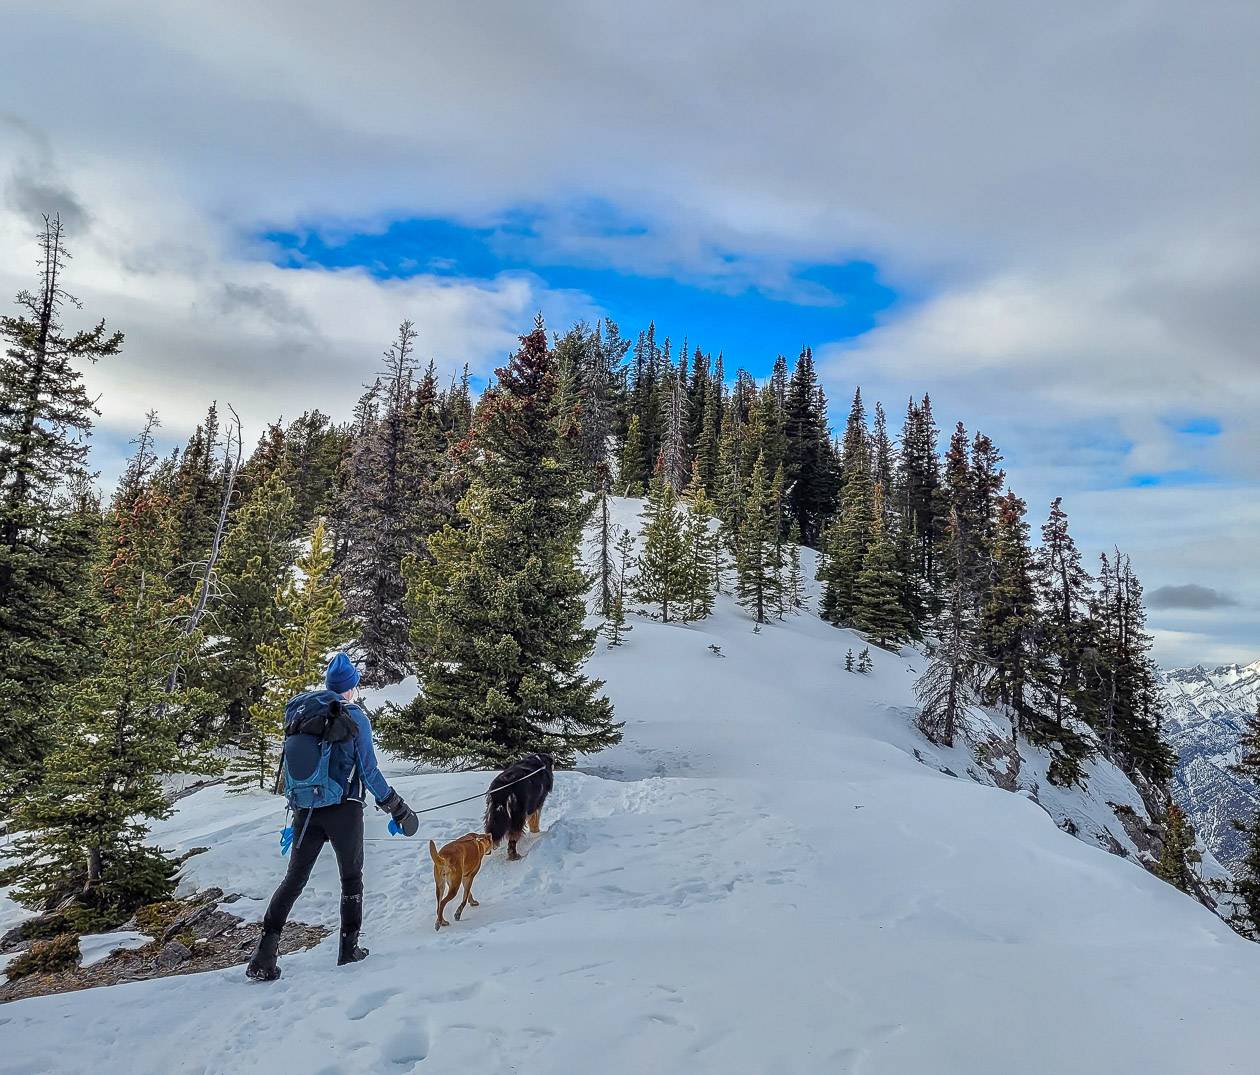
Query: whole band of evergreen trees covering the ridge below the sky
xmin=0 ymin=218 xmax=1239 ymax=937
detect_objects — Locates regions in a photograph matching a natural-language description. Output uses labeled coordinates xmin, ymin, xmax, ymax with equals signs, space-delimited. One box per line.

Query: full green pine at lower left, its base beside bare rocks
xmin=0 ymin=439 xmax=207 ymax=928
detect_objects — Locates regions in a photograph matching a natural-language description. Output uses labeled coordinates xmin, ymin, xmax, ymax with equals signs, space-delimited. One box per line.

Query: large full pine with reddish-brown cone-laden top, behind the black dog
xmin=386 ymin=320 xmax=621 ymax=767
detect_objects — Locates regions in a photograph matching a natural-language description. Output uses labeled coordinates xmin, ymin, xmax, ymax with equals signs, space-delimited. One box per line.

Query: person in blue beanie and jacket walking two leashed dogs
xmin=244 ymin=653 xmax=420 ymax=982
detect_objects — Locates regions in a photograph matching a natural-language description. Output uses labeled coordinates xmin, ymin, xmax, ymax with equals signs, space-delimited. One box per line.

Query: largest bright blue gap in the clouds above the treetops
xmin=257 ymin=210 xmax=908 ymax=377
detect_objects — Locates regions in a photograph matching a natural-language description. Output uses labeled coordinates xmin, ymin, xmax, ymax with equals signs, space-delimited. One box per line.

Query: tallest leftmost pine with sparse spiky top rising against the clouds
xmin=0 ymin=217 xmax=122 ymax=802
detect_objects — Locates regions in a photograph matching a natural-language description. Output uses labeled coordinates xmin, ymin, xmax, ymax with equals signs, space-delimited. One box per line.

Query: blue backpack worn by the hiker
xmin=282 ymin=691 xmax=355 ymax=811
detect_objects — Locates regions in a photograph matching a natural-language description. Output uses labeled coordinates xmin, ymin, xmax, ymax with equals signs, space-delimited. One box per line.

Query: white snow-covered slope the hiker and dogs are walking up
xmin=0 ymin=505 xmax=1260 ymax=1075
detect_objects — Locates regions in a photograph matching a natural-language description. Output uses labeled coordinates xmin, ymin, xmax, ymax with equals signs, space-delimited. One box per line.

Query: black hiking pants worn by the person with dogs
xmin=262 ymin=799 xmax=363 ymax=933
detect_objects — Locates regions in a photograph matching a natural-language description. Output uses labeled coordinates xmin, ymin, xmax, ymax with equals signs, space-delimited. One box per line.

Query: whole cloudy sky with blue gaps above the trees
xmin=0 ymin=0 xmax=1260 ymax=664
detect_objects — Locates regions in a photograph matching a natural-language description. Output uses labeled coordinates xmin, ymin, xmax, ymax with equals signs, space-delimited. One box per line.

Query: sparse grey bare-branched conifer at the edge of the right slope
xmin=915 ymin=508 xmax=978 ymax=746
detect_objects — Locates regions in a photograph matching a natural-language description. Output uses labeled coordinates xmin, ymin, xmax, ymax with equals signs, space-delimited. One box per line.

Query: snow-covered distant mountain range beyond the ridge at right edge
xmin=1160 ymin=660 xmax=1260 ymax=868
